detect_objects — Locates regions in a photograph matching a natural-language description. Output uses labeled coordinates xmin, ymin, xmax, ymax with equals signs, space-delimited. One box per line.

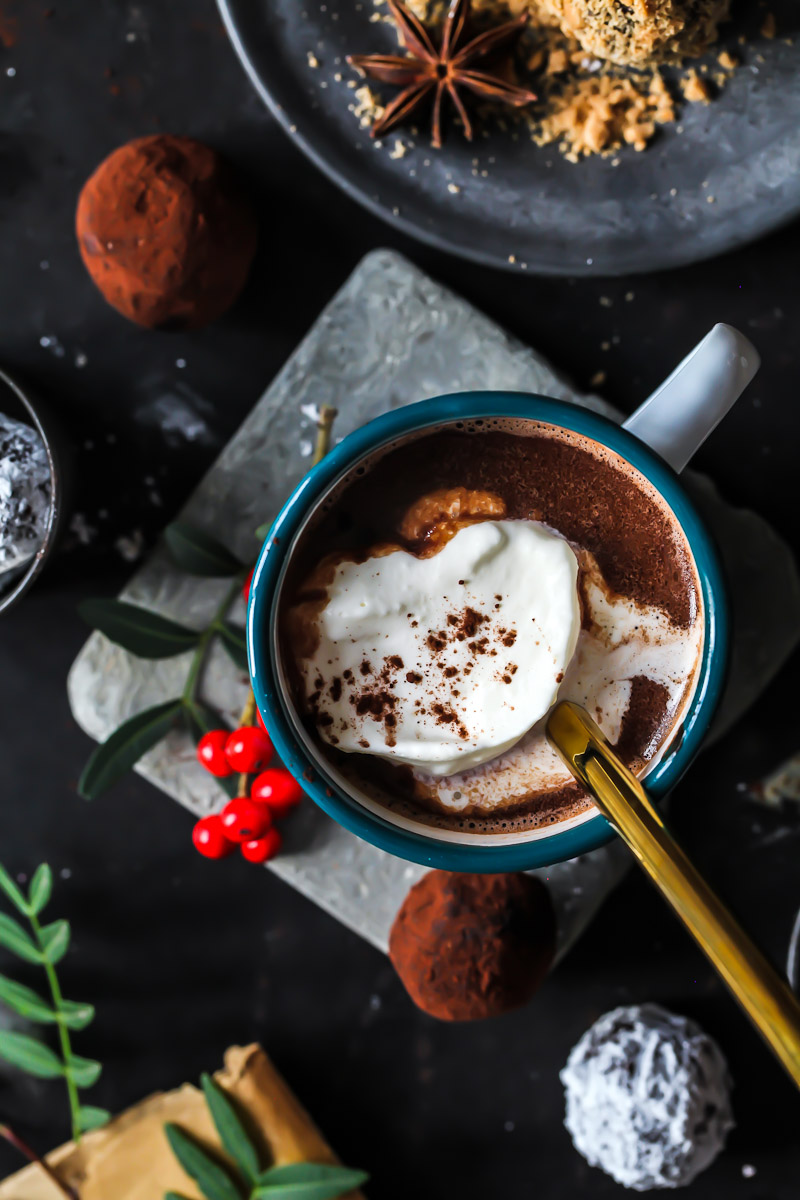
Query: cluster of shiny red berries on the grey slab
xmin=192 ymin=714 xmax=302 ymax=863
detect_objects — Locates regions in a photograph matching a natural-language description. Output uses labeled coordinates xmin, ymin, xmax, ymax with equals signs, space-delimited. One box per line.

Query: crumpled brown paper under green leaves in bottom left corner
xmin=0 ymin=1045 xmax=363 ymax=1200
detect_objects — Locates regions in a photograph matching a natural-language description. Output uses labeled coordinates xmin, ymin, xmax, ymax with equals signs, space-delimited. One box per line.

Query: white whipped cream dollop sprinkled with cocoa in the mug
xmin=293 ymin=521 xmax=581 ymax=775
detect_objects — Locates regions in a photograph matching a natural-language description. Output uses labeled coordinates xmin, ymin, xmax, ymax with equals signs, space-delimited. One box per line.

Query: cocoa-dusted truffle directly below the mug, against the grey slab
xmin=389 ymin=871 xmax=555 ymax=1021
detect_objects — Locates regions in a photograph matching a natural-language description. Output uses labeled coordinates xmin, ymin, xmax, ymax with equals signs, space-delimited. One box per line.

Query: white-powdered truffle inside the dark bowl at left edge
xmin=0 ymin=413 xmax=50 ymax=574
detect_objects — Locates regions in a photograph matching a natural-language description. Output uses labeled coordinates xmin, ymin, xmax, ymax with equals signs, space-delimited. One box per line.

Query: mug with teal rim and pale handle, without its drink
xmin=247 ymin=325 xmax=758 ymax=872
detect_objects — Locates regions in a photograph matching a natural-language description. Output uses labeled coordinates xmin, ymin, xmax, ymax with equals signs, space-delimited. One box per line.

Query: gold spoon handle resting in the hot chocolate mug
xmin=547 ymin=701 xmax=800 ymax=1087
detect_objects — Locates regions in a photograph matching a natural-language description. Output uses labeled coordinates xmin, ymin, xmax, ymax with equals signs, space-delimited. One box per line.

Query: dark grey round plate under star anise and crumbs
xmin=218 ymin=0 xmax=800 ymax=275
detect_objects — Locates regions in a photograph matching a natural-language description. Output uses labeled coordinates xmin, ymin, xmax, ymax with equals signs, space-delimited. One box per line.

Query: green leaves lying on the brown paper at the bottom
xmin=164 ymin=1075 xmax=368 ymax=1200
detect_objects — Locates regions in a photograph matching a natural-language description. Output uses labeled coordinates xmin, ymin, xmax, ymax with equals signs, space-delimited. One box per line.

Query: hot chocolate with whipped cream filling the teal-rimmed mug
xmin=281 ymin=418 xmax=703 ymax=833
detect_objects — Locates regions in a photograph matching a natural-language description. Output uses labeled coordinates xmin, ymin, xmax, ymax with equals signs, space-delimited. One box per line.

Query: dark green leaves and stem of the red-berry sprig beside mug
xmin=78 ymin=407 xmax=336 ymax=799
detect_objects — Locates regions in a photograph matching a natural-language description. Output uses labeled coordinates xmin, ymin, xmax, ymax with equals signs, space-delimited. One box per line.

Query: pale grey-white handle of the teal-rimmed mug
xmin=622 ymin=325 xmax=762 ymax=472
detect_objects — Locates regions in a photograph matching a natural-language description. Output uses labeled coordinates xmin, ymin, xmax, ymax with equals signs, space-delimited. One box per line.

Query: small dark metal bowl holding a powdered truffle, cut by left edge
xmin=0 ymin=371 xmax=65 ymax=613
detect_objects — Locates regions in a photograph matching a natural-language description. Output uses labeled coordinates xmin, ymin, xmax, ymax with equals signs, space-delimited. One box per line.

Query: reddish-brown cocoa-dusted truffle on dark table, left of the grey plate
xmin=76 ymin=134 xmax=257 ymax=329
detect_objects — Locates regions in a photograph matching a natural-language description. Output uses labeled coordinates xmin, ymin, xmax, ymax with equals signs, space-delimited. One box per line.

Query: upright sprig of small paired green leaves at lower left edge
xmin=0 ymin=863 xmax=110 ymax=1194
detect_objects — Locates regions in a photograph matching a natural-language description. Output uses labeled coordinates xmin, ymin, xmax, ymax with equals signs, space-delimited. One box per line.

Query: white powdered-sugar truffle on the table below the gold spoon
xmin=561 ymin=1004 xmax=734 ymax=1192
